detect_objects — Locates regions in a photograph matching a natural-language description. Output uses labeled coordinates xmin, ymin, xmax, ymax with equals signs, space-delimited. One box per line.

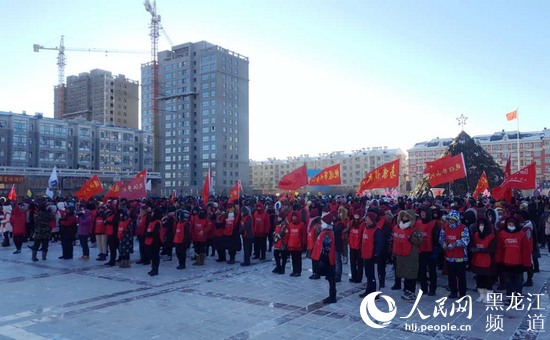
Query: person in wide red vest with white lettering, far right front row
xmin=495 ymin=217 xmax=531 ymax=296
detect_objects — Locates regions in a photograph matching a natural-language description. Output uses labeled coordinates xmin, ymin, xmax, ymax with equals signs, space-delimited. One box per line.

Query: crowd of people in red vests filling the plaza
xmin=0 ymin=195 xmax=550 ymax=303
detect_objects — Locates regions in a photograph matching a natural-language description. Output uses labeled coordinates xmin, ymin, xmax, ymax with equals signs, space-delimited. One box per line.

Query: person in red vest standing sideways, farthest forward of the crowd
xmin=312 ymin=213 xmax=336 ymax=304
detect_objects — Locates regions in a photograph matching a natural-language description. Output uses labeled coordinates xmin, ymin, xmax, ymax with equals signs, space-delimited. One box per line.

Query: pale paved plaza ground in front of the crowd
xmin=0 ymin=243 xmax=550 ymax=339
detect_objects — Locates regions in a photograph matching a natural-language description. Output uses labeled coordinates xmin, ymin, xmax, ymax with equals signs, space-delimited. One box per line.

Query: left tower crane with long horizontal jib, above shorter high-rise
xmin=32 ymin=35 xmax=148 ymax=117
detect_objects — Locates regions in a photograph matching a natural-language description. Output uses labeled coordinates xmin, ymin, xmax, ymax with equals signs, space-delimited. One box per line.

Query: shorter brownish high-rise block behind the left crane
xmin=54 ymin=69 xmax=139 ymax=129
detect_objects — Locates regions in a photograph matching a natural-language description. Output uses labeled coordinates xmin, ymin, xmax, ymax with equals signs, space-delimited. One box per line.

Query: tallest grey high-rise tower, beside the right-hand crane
xmin=141 ymin=41 xmax=253 ymax=195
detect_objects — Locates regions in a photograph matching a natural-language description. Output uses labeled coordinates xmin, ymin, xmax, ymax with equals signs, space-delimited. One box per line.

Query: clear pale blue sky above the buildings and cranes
xmin=0 ymin=0 xmax=550 ymax=160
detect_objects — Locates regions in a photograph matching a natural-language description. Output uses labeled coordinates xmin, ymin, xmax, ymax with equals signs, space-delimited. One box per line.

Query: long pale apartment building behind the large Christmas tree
xmin=408 ymin=128 xmax=550 ymax=187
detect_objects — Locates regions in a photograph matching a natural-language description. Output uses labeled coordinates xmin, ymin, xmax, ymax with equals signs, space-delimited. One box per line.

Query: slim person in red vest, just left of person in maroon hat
xmin=348 ymin=210 xmax=365 ymax=283
